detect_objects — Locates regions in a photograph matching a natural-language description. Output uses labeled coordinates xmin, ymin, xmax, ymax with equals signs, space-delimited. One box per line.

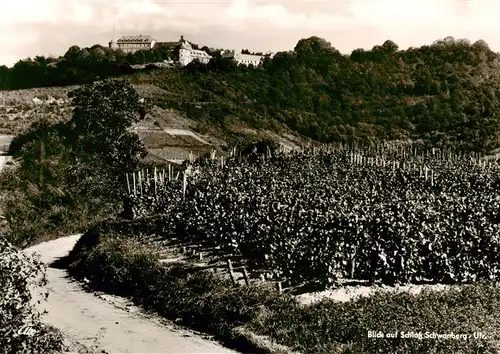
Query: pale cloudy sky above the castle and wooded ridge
xmin=0 ymin=0 xmax=500 ymax=67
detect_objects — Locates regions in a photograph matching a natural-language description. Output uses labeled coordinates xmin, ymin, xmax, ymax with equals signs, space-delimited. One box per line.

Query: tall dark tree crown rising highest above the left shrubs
xmin=69 ymin=80 xmax=147 ymax=174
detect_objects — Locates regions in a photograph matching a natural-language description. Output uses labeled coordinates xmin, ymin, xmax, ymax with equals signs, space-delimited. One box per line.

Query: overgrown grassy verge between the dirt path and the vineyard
xmin=63 ymin=219 xmax=500 ymax=354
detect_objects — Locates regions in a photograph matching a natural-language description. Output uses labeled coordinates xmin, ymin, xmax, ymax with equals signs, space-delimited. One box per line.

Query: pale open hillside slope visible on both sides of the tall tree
xmin=0 ymin=84 xmax=303 ymax=162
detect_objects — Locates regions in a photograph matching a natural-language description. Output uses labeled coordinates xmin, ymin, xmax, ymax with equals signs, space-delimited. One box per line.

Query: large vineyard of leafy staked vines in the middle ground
xmin=127 ymin=145 xmax=500 ymax=286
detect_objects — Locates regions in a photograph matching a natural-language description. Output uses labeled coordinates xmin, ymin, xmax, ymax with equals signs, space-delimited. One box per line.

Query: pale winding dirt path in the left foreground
xmin=25 ymin=235 xmax=236 ymax=354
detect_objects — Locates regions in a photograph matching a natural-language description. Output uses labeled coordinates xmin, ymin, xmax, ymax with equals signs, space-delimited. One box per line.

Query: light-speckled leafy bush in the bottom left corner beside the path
xmin=0 ymin=235 xmax=63 ymax=354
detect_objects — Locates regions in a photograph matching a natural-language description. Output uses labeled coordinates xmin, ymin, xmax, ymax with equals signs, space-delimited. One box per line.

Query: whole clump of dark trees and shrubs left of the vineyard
xmin=0 ymin=80 xmax=146 ymax=246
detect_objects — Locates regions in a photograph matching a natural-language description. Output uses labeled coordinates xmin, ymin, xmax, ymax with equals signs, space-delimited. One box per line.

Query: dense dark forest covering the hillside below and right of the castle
xmin=0 ymin=37 xmax=500 ymax=151
